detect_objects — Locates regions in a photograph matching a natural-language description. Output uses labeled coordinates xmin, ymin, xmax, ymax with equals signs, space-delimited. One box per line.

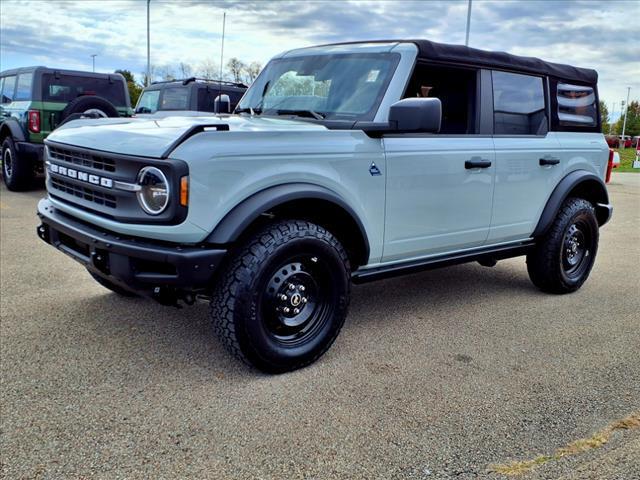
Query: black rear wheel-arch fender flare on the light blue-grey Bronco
xmin=531 ymin=170 xmax=611 ymax=237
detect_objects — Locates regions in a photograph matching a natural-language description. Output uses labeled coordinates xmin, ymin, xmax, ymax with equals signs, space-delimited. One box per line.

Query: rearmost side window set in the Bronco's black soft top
xmin=557 ymin=83 xmax=598 ymax=127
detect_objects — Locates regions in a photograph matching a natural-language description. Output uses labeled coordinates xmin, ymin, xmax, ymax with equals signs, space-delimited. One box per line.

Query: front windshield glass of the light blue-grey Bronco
xmin=236 ymin=53 xmax=400 ymax=121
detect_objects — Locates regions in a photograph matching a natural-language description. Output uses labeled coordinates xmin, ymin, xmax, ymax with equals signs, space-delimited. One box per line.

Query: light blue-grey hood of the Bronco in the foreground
xmin=48 ymin=112 xmax=326 ymax=158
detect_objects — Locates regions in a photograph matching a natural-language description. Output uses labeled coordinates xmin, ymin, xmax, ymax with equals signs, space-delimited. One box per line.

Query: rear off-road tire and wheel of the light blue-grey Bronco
xmin=527 ymin=198 xmax=599 ymax=293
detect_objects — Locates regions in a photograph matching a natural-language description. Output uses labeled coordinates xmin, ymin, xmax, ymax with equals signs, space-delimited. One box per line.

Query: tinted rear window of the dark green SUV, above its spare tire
xmin=42 ymin=73 xmax=126 ymax=107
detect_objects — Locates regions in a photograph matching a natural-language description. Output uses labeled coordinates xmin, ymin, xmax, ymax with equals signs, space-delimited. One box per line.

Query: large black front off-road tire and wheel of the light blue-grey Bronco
xmin=210 ymin=220 xmax=350 ymax=373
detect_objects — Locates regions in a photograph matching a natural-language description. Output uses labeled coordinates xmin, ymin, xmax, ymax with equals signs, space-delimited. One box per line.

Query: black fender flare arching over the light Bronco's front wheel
xmin=206 ymin=183 xmax=369 ymax=258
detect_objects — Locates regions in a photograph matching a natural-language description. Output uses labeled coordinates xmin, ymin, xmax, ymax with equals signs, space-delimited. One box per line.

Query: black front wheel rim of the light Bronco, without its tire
xmin=261 ymin=254 xmax=336 ymax=347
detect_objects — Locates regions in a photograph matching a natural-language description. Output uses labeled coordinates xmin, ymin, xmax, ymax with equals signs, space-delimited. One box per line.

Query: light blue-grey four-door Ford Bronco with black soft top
xmin=37 ymin=40 xmax=612 ymax=373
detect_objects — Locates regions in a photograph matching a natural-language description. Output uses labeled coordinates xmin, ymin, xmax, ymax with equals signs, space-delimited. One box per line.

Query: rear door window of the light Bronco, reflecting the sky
xmin=492 ymin=72 xmax=548 ymax=135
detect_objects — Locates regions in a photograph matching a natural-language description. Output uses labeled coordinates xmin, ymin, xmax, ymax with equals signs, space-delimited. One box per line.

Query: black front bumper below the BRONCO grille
xmin=37 ymin=199 xmax=227 ymax=304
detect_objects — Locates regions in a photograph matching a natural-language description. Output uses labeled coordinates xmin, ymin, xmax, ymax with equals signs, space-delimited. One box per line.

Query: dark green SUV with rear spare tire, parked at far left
xmin=0 ymin=67 xmax=133 ymax=191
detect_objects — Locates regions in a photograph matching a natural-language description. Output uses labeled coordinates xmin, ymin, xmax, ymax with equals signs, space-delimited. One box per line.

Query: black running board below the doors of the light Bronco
xmin=351 ymin=240 xmax=535 ymax=283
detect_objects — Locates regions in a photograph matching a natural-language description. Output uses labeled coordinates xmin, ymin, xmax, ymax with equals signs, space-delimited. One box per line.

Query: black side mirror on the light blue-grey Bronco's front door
xmin=389 ymin=98 xmax=442 ymax=133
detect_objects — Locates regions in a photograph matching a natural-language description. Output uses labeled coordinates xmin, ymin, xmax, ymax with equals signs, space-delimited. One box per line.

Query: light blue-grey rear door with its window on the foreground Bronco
xmin=483 ymin=71 xmax=563 ymax=244
